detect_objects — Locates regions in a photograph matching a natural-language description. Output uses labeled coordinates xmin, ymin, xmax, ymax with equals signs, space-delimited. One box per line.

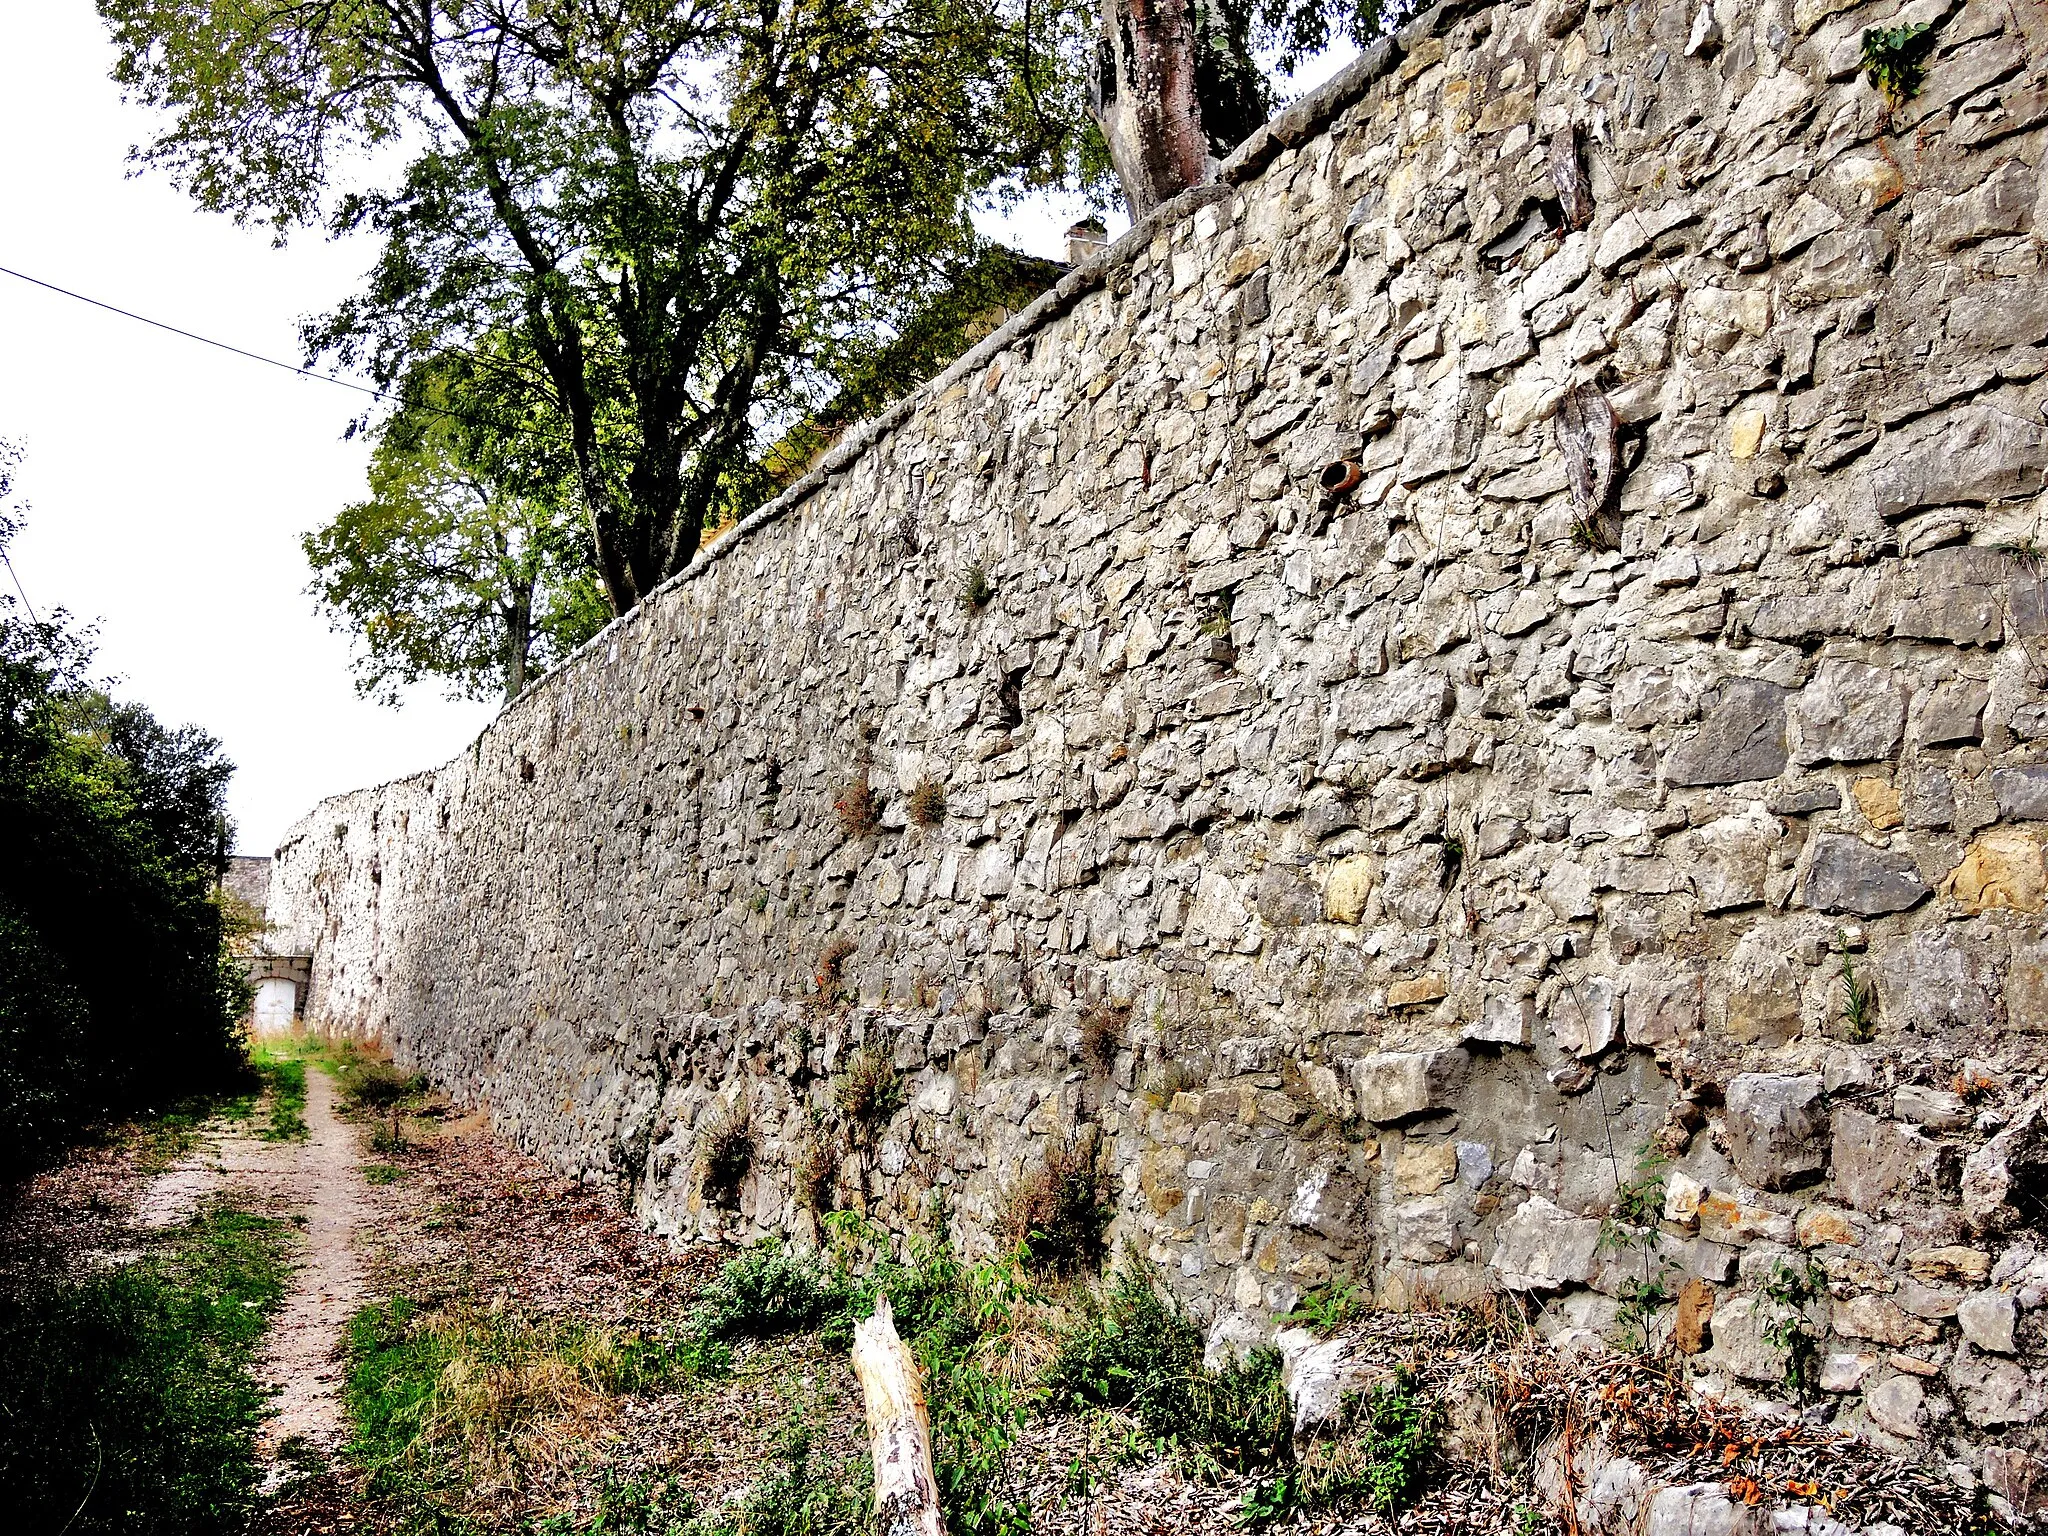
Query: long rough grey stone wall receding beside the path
xmin=272 ymin=0 xmax=2048 ymax=1503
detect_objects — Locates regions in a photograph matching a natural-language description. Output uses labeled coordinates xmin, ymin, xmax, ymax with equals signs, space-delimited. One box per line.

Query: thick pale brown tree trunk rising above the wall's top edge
xmin=1090 ymin=0 xmax=1266 ymax=221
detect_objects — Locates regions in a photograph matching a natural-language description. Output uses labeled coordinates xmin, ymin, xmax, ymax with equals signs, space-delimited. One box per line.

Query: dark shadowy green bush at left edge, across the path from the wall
xmin=0 ymin=442 xmax=250 ymax=1176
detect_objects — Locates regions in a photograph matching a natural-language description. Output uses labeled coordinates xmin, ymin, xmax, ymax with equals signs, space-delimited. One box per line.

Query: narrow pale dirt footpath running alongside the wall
xmin=252 ymin=1069 xmax=369 ymax=1458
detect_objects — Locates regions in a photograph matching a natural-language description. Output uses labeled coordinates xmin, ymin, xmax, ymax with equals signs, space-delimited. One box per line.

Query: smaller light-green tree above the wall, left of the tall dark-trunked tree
xmin=303 ymin=367 xmax=612 ymax=705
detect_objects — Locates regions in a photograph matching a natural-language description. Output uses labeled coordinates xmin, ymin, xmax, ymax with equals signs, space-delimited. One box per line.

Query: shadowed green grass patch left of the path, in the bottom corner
xmin=0 ymin=1208 xmax=285 ymax=1536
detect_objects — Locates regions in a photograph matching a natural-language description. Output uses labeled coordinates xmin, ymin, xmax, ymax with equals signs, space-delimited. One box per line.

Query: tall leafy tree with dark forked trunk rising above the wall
xmin=98 ymin=0 xmax=1075 ymax=612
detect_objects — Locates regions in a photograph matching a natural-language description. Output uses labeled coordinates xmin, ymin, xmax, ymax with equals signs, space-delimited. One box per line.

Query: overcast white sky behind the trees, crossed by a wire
xmin=0 ymin=0 xmax=1339 ymax=852
